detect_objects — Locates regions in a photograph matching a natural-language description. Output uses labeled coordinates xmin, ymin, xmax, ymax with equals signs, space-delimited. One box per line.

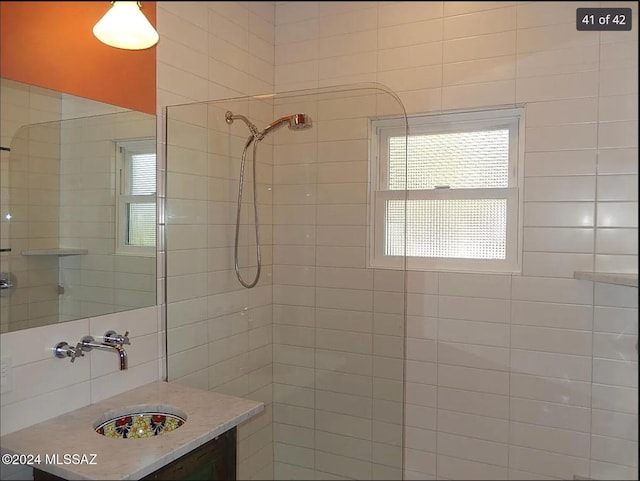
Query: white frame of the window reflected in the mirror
xmin=115 ymin=138 xmax=158 ymax=257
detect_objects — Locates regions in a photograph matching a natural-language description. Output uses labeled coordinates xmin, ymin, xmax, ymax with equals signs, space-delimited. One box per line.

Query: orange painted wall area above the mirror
xmin=0 ymin=1 xmax=157 ymax=115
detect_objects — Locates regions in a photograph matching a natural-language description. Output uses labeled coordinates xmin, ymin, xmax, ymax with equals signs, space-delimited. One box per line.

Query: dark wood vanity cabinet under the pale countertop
xmin=33 ymin=427 xmax=237 ymax=481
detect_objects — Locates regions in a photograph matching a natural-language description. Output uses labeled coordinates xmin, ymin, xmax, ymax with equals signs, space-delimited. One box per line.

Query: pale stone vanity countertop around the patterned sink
xmin=0 ymin=381 xmax=264 ymax=480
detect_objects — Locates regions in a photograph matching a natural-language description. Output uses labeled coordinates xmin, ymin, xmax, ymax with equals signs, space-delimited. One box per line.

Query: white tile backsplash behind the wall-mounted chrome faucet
xmin=0 ymin=306 xmax=162 ymax=434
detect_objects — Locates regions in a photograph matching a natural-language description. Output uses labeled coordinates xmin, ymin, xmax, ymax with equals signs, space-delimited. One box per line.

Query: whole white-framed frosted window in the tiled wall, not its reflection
xmin=369 ymin=108 xmax=523 ymax=272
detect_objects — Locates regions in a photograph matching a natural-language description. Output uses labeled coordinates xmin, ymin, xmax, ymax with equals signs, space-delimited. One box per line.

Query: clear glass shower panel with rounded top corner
xmin=166 ymin=84 xmax=406 ymax=479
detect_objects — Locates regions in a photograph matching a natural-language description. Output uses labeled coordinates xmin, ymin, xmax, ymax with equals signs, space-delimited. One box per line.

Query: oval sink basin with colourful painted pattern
xmin=93 ymin=405 xmax=187 ymax=439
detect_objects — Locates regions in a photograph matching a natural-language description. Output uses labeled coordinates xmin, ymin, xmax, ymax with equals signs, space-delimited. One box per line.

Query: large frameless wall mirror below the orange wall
xmin=0 ymin=79 xmax=157 ymax=332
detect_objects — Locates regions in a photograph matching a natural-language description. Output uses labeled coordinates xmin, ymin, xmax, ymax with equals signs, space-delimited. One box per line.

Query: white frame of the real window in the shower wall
xmin=368 ymin=107 xmax=524 ymax=273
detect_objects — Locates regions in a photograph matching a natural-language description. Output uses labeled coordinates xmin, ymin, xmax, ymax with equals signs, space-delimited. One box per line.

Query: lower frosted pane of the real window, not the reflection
xmin=385 ymin=199 xmax=507 ymax=259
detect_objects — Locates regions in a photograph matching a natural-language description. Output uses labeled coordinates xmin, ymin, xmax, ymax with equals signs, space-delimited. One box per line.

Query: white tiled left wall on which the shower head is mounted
xmin=157 ymin=2 xmax=281 ymax=479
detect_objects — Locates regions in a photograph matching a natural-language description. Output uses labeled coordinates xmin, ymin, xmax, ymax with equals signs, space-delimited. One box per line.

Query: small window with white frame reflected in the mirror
xmin=116 ymin=140 xmax=156 ymax=256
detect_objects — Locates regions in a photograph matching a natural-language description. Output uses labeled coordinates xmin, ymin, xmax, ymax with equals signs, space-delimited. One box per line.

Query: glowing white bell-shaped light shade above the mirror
xmin=93 ymin=2 xmax=160 ymax=50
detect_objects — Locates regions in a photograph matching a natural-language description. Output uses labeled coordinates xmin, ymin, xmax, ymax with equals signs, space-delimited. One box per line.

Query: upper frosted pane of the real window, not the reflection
xmin=388 ymin=129 xmax=509 ymax=190
